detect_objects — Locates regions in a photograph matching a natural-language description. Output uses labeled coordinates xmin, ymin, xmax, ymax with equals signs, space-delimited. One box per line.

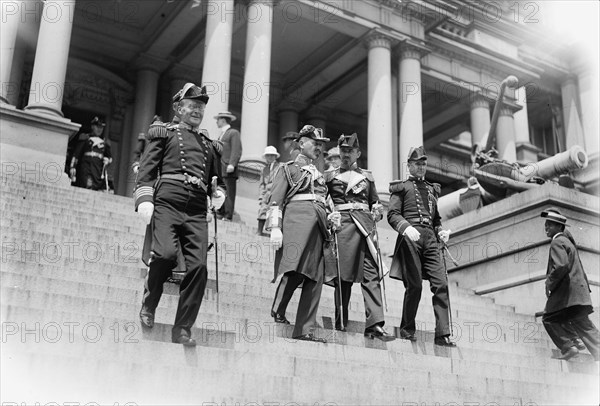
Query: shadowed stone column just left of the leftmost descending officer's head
xmin=122 ymin=63 xmax=160 ymax=190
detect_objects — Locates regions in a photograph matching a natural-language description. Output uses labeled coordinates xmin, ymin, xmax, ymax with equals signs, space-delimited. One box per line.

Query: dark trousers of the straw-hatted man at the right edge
xmin=542 ymin=306 xmax=600 ymax=361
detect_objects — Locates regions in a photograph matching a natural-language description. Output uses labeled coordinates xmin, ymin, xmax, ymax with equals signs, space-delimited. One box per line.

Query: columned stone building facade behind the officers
xmin=0 ymin=0 xmax=599 ymax=195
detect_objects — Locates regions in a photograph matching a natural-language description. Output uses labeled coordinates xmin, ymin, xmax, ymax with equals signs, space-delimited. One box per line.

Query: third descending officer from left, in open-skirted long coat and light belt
xmin=325 ymin=133 xmax=395 ymax=341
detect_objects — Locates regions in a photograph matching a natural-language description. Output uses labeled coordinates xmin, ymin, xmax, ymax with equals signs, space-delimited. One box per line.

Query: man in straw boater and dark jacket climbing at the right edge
xmin=542 ymin=209 xmax=600 ymax=361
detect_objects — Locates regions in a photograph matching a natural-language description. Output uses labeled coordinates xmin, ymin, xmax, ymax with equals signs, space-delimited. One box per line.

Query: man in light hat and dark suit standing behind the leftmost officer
xmin=214 ymin=111 xmax=242 ymax=220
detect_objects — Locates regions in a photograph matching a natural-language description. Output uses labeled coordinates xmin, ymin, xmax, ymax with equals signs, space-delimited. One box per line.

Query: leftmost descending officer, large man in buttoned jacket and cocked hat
xmin=134 ymin=83 xmax=225 ymax=346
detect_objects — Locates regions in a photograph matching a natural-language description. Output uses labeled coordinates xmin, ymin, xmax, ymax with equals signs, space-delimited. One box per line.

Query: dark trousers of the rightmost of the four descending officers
xmin=400 ymin=224 xmax=450 ymax=337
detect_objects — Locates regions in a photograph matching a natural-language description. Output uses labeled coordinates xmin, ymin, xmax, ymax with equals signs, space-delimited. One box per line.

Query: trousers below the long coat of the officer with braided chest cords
xmin=272 ymin=271 xmax=323 ymax=337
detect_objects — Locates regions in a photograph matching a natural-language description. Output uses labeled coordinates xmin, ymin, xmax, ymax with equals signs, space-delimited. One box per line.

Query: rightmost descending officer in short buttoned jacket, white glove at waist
xmin=387 ymin=146 xmax=456 ymax=347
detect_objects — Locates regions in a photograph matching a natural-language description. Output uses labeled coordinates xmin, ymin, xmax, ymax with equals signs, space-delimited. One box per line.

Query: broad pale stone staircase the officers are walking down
xmin=0 ymin=174 xmax=599 ymax=405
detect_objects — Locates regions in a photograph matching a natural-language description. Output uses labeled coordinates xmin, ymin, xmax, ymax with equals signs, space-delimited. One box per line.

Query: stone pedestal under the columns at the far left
xmin=0 ymin=104 xmax=81 ymax=187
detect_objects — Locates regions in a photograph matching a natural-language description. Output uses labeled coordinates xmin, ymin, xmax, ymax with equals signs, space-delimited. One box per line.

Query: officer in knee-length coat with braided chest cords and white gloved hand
xmin=266 ymin=125 xmax=329 ymax=343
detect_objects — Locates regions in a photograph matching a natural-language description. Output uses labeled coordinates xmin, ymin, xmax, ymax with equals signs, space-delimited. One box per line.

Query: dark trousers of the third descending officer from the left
xmin=335 ymin=250 xmax=385 ymax=329
